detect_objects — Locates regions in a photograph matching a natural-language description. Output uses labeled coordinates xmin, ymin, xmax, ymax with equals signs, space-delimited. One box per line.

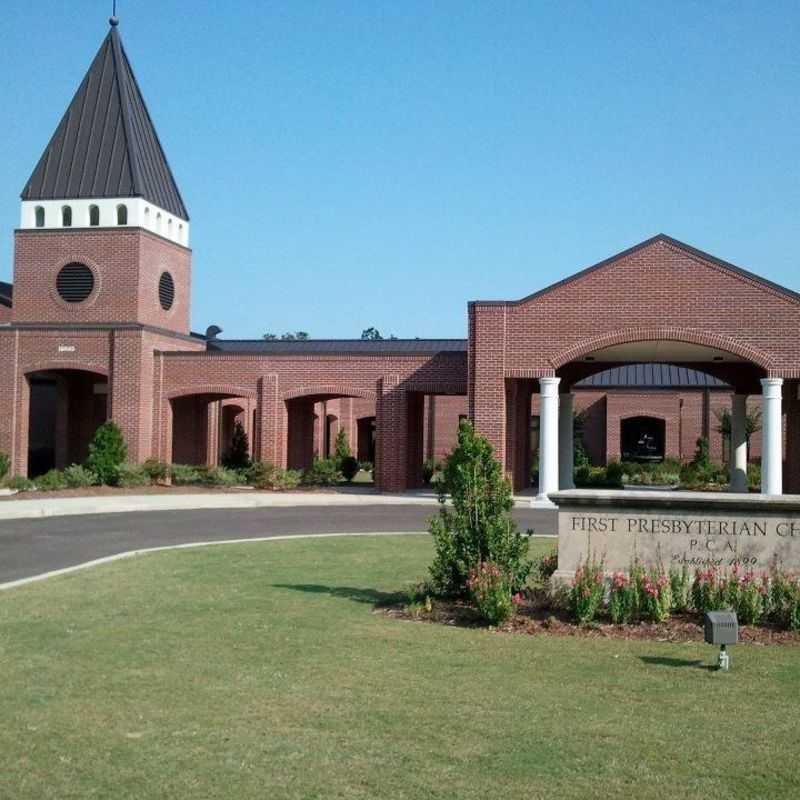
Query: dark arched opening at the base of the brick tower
xmin=27 ymin=369 xmax=108 ymax=477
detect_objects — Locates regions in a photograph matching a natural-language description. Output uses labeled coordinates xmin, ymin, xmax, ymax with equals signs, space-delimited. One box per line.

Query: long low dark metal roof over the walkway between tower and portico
xmin=208 ymin=339 xmax=467 ymax=355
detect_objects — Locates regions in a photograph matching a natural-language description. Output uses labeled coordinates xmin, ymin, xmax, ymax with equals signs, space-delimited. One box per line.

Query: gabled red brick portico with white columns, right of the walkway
xmin=469 ymin=236 xmax=800 ymax=505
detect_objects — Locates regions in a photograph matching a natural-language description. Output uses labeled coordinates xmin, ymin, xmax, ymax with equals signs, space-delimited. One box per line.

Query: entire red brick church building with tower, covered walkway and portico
xmin=0 ymin=19 xmax=800 ymax=500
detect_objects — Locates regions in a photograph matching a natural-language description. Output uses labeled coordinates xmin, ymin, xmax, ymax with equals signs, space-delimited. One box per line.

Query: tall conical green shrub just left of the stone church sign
xmin=429 ymin=420 xmax=532 ymax=595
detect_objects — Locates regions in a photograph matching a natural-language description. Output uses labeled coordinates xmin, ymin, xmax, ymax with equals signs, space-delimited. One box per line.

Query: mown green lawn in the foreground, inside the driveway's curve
xmin=0 ymin=536 xmax=800 ymax=800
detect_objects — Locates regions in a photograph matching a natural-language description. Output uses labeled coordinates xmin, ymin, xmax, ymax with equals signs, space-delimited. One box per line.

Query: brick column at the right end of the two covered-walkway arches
xmin=375 ymin=375 xmax=408 ymax=492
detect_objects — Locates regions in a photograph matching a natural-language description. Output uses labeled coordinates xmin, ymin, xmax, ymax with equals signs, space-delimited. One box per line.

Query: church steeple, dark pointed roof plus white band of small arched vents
xmin=21 ymin=17 xmax=189 ymax=243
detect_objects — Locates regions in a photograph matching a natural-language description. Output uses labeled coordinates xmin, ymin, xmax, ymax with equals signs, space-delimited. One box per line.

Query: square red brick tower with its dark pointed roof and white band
xmin=0 ymin=18 xmax=202 ymax=474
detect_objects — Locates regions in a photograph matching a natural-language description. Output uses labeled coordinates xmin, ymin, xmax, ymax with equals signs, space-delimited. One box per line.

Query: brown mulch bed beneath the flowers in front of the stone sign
xmin=375 ymin=600 xmax=800 ymax=645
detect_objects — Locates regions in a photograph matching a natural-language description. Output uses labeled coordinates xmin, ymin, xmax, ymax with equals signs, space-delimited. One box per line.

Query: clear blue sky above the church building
xmin=0 ymin=0 xmax=800 ymax=337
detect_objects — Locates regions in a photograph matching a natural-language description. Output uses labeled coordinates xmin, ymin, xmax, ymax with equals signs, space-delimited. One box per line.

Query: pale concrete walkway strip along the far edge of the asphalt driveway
xmin=0 ymin=492 xmax=530 ymax=522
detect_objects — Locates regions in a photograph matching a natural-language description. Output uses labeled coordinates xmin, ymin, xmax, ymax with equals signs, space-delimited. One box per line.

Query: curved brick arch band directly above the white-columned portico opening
xmin=550 ymin=327 xmax=772 ymax=372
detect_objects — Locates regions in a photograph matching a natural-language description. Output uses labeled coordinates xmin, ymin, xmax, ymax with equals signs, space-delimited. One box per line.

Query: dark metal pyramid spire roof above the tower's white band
xmin=22 ymin=20 xmax=189 ymax=220
